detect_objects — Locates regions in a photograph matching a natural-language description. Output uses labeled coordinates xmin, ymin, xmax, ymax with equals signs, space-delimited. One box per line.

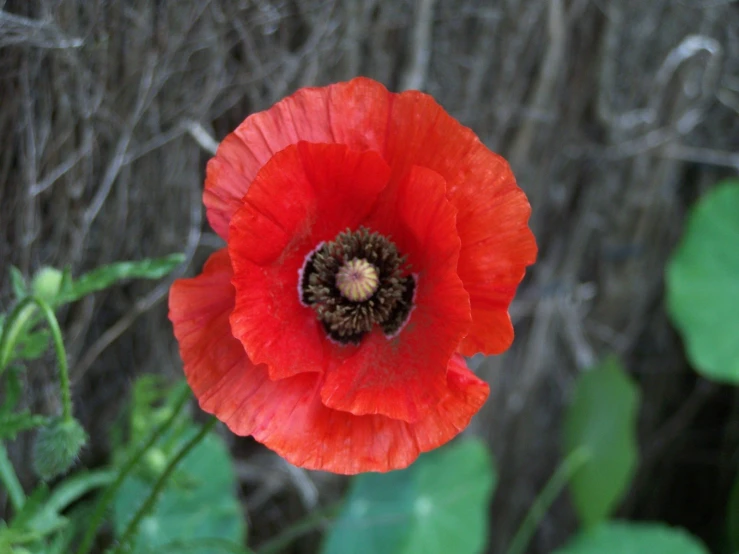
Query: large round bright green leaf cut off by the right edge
xmin=666 ymin=180 xmax=739 ymax=384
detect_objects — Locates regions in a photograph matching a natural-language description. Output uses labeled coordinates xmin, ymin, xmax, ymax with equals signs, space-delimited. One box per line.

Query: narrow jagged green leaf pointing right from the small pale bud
xmin=57 ymin=254 xmax=185 ymax=304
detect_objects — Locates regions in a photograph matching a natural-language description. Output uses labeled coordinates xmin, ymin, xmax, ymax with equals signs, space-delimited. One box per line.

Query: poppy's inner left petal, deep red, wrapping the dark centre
xmin=228 ymin=143 xmax=389 ymax=379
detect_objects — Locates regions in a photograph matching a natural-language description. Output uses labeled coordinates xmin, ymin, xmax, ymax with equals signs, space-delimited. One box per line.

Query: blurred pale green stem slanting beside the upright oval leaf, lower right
xmin=508 ymin=447 xmax=590 ymax=554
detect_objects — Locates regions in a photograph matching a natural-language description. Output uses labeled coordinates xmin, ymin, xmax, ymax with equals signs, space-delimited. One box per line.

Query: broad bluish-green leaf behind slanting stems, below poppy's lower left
xmin=113 ymin=434 xmax=245 ymax=554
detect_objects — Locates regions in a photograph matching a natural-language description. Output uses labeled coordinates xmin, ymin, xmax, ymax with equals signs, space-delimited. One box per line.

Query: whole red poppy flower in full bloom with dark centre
xmin=169 ymin=78 xmax=536 ymax=473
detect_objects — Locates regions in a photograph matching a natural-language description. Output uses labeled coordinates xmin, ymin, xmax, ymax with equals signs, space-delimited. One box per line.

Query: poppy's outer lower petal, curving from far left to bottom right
xmin=169 ymin=250 xmax=489 ymax=474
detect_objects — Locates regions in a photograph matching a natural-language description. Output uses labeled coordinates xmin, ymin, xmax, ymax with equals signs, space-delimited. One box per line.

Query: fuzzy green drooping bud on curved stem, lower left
xmin=33 ymin=418 xmax=87 ymax=481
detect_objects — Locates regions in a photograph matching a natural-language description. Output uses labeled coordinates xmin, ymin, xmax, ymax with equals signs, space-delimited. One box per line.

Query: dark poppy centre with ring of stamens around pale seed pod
xmin=300 ymin=227 xmax=416 ymax=344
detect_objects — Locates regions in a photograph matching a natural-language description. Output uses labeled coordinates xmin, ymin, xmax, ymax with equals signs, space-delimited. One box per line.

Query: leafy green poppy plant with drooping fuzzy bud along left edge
xmin=0 ymin=254 xmax=198 ymax=554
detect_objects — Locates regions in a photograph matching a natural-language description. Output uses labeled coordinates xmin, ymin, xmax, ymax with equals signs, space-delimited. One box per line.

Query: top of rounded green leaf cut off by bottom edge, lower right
xmin=555 ymin=521 xmax=709 ymax=554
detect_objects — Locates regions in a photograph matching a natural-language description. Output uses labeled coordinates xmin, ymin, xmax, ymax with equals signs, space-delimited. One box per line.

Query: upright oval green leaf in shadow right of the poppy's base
xmin=564 ymin=358 xmax=639 ymax=526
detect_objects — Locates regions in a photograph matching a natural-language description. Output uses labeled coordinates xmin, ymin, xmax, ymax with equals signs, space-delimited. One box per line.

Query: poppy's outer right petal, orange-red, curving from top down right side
xmin=385 ymin=91 xmax=536 ymax=355
